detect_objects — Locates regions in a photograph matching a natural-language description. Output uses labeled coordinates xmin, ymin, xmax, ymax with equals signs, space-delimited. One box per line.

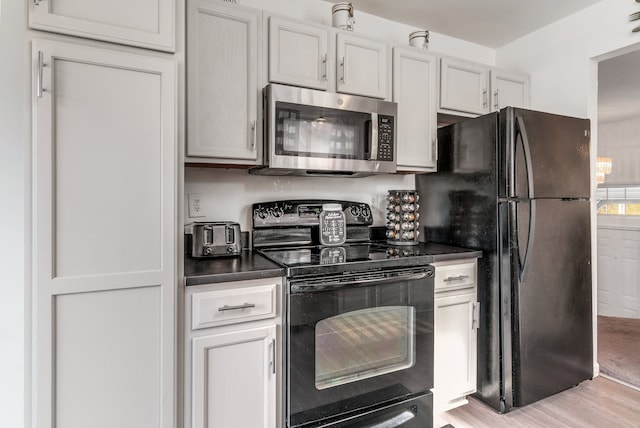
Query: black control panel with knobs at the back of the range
xmin=253 ymin=199 xmax=373 ymax=229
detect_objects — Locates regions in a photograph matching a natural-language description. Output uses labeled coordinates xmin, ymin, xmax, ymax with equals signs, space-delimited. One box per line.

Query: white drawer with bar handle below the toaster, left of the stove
xmin=191 ymin=283 xmax=276 ymax=330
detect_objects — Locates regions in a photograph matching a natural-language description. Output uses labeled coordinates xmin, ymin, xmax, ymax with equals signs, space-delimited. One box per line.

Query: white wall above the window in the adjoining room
xmin=598 ymin=118 xmax=640 ymax=185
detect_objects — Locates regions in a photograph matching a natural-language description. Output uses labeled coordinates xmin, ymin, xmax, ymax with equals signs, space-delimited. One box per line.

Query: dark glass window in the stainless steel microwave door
xmin=275 ymin=102 xmax=371 ymax=160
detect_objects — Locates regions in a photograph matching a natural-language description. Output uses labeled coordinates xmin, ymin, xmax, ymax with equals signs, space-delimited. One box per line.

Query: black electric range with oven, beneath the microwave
xmin=253 ymin=200 xmax=434 ymax=428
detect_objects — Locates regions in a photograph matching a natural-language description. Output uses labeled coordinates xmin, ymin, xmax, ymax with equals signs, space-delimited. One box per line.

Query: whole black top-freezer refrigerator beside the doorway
xmin=416 ymin=107 xmax=593 ymax=413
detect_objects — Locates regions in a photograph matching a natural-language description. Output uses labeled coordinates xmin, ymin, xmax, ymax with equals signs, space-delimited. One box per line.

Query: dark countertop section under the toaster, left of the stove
xmin=184 ymin=251 xmax=284 ymax=285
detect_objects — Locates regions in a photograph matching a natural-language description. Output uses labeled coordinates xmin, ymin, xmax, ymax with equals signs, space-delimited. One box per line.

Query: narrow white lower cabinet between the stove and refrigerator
xmin=433 ymin=259 xmax=479 ymax=414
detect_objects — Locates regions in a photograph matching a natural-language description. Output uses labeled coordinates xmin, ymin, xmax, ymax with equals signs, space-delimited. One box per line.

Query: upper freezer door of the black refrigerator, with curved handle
xmin=499 ymin=107 xmax=590 ymax=199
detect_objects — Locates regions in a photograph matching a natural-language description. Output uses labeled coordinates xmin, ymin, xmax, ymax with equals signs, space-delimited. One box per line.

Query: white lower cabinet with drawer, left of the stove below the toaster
xmin=185 ymin=278 xmax=282 ymax=428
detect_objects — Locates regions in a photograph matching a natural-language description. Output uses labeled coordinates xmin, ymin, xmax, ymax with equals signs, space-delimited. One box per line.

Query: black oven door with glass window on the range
xmin=287 ymin=266 xmax=433 ymax=427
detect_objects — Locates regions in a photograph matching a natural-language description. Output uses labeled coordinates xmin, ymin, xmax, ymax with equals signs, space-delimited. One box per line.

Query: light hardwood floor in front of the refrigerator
xmin=433 ymin=376 xmax=640 ymax=428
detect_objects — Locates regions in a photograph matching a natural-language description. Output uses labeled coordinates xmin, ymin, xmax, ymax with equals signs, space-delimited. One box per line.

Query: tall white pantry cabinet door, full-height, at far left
xmin=32 ymin=40 xmax=177 ymax=428
